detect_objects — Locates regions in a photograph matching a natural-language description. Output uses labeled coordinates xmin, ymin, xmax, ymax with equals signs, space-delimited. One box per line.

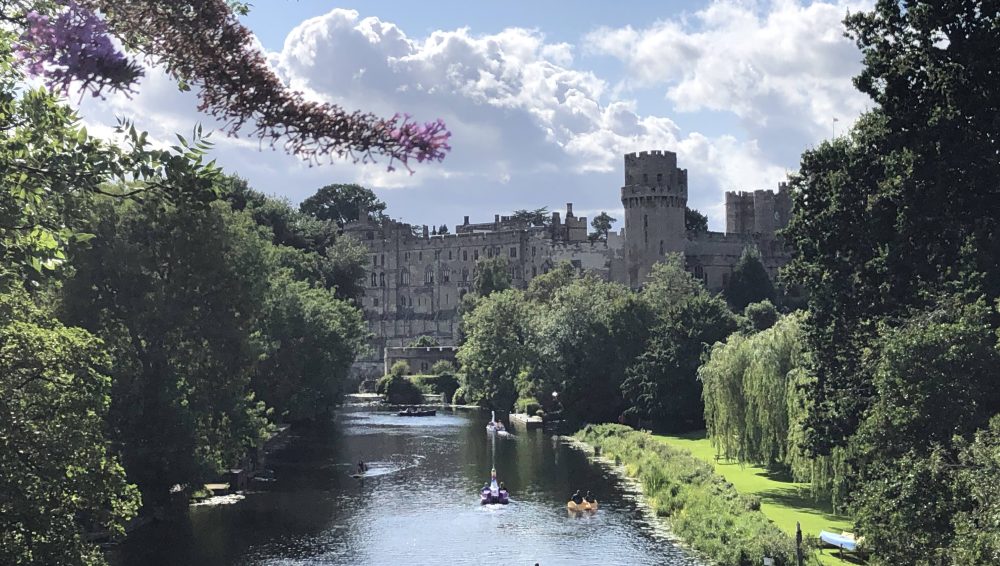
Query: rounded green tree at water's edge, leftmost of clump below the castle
xmin=458 ymin=289 xmax=535 ymax=410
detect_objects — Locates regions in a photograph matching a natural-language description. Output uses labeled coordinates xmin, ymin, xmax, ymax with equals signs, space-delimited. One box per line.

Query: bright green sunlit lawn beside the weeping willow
xmin=654 ymin=432 xmax=856 ymax=565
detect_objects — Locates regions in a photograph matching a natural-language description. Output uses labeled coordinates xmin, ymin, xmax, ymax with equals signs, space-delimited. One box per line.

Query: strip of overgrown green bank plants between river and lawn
xmin=575 ymin=425 xmax=800 ymax=566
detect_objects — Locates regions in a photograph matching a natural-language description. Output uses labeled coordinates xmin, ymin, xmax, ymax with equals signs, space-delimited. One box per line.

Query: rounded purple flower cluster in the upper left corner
xmin=15 ymin=0 xmax=142 ymax=96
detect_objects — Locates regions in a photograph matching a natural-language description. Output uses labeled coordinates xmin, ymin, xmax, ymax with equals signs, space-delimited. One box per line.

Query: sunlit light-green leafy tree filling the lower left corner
xmin=0 ymin=286 xmax=139 ymax=565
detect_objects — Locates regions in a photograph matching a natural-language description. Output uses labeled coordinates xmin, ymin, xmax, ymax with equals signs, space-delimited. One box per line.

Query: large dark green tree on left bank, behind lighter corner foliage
xmin=62 ymin=199 xmax=273 ymax=503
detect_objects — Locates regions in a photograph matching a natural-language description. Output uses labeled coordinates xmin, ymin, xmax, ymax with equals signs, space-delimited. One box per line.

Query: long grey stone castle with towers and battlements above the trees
xmin=344 ymin=151 xmax=791 ymax=377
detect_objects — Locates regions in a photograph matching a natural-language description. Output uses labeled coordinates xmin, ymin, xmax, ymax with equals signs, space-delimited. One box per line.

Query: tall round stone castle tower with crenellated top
xmin=621 ymin=151 xmax=687 ymax=287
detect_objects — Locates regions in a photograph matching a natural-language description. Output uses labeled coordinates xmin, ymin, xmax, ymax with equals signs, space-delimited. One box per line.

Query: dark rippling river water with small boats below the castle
xmin=111 ymin=409 xmax=699 ymax=566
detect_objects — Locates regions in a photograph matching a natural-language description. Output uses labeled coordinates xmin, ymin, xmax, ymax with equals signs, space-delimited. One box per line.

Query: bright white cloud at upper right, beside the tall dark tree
xmin=584 ymin=0 xmax=871 ymax=163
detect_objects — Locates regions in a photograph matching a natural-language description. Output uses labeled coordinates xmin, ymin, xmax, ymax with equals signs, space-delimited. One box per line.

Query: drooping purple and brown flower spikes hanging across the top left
xmin=0 ymin=0 xmax=450 ymax=170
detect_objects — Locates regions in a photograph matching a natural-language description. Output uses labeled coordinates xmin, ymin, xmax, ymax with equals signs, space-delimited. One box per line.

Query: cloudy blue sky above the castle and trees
xmin=81 ymin=0 xmax=871 ymax=231
